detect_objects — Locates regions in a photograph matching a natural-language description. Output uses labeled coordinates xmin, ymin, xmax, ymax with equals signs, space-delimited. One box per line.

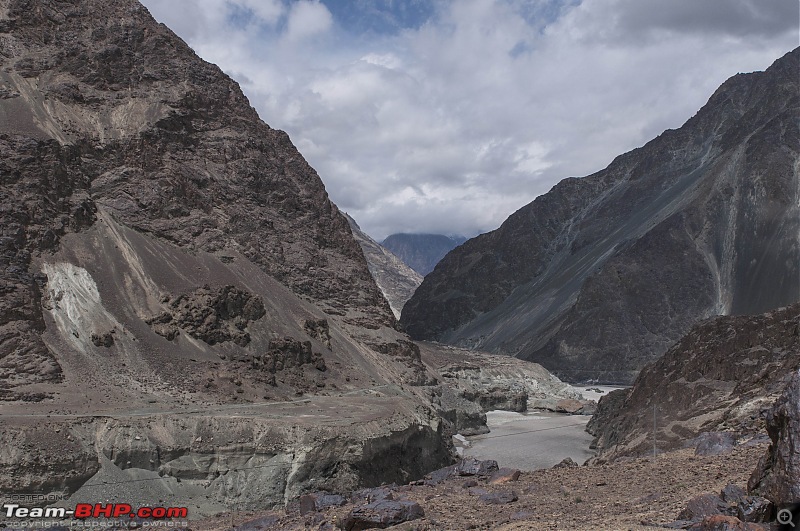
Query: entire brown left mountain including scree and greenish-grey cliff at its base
xmin=0 ymin=0 xmax=588 ymax=518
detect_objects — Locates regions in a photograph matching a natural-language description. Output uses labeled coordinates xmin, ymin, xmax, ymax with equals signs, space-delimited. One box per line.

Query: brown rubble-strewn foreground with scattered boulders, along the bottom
xmin=192 ymin=368 xmax=800 ymax=531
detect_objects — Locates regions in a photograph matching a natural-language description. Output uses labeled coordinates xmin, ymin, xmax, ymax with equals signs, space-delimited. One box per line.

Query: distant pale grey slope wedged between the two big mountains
xmin=345 ymin=214 xmax=422 ymax=319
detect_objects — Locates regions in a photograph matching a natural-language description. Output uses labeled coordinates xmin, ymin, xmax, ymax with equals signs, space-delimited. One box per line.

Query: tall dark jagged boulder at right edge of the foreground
xmin=747 ymin=370 xmax=800 ymax=505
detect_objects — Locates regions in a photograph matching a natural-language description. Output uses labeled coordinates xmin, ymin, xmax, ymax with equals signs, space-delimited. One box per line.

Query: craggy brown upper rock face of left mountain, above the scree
xmin=0 ymin=0 xmax=394 ymax=400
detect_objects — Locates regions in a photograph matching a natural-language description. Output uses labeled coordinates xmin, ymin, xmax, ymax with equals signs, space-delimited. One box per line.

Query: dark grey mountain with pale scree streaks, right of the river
xmin=400 ymin=49 xmax=800 ymax=383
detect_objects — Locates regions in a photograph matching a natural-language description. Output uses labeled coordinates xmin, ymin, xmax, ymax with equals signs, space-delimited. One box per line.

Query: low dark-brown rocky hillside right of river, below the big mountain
xmin=587 ymin=304 xmax=800 ymax=461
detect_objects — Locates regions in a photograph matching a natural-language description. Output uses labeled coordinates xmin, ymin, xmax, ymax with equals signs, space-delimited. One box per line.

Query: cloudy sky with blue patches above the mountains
xmin=142 ymin=0 xmax=800 ymax=240
